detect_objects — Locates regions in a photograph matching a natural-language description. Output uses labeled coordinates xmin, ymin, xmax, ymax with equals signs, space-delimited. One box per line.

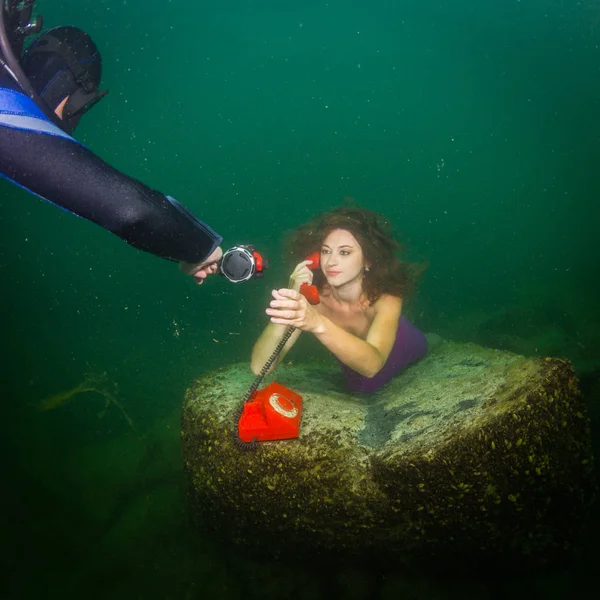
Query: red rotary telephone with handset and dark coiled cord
xmin=237 ymin=251 xmax=321 ymax=448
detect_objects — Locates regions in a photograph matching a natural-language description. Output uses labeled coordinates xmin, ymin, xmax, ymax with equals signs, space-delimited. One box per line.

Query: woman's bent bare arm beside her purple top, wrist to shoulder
xmin=313 ymin=296 xmax=402 ymax=377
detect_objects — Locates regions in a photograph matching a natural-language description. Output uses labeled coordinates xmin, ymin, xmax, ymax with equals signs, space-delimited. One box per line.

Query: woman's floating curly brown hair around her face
xmin=287 ymin=199 xmax=423 ymax=304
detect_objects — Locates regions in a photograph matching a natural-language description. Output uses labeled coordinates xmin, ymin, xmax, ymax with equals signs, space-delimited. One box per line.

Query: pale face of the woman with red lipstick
xmin=321 ymin=229 xmax=365 ymax=287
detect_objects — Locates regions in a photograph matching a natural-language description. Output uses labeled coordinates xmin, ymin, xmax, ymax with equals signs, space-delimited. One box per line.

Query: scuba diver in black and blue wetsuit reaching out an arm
xmin=0 ymin=0 xmax=223 ymax=284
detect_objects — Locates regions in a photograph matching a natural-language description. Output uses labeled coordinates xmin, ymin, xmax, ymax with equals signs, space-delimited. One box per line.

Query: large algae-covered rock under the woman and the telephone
xmin=181 ymin=342 xmax=594 ymax=566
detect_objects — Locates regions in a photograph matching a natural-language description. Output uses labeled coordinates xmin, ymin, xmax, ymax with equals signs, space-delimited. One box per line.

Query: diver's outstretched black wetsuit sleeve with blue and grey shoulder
xmin=0 ymin=67 xmax=222 ymax=263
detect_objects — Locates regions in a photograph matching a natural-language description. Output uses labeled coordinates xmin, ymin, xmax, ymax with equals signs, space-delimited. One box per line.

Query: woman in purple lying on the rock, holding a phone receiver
xmin=251 ymin=206 xmax=427 ymax=393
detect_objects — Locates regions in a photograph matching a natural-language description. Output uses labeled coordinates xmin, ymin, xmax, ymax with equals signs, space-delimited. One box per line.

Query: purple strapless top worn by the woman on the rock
xmin=338 ymin=316 xmax=427 ymax=393
